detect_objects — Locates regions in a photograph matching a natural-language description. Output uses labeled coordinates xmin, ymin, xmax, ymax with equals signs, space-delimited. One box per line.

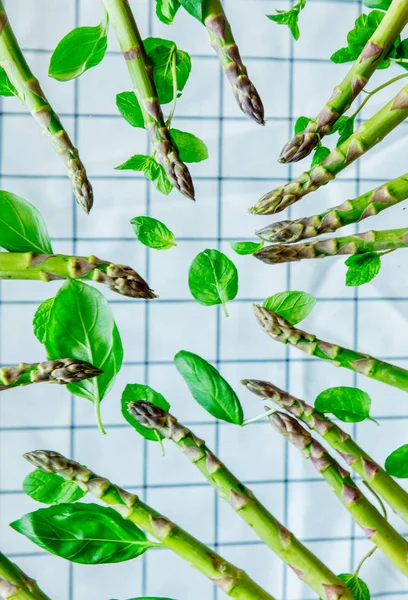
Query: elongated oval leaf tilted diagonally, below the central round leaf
xmin=174 ymin=350 xmax=244 ymax=425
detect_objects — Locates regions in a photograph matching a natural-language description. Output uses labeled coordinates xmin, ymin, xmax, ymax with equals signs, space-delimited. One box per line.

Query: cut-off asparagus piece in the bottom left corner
xmin=0 ymin=552 xmax=50 ymax=600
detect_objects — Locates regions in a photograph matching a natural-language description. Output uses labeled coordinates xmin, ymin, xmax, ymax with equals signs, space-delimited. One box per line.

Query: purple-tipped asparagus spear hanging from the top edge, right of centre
xmin=203 ymin=0 xmax=265 ymax=125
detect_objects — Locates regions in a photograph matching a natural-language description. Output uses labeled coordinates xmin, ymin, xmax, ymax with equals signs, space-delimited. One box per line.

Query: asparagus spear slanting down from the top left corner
xmin=0 ymin=0 xmax=93 ymax=213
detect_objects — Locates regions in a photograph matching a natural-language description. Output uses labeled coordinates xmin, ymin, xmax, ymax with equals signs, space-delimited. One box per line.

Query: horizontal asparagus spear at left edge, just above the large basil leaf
xmin=0 ymin=252 xmax=157 ymax=299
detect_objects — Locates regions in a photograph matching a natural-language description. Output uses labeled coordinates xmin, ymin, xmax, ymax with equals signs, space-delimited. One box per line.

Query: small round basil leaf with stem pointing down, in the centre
xmin=188 ymin=249 xmax=238 ymax=316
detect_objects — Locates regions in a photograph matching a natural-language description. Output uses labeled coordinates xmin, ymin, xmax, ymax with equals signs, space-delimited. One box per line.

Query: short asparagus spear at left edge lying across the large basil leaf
xmin=0 ymin=358 xmax=103 ymax=392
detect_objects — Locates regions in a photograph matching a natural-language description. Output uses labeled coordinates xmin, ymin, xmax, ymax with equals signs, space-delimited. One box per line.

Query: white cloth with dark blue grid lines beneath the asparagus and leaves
xmin=0 ymin=0 xmax=408 ymax=600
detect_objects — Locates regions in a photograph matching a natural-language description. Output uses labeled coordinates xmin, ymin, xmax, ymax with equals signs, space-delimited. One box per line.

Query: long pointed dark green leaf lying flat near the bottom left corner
xmin=10 ymin=504 xmax=155 ymax=565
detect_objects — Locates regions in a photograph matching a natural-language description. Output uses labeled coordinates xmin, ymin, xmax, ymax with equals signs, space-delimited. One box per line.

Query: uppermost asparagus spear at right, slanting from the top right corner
xmin=279 ymin=0 xmax=408 ymax=163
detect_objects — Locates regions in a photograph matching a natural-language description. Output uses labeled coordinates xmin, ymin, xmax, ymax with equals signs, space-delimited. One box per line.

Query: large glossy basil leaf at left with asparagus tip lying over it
xmin=45 ymin=279 xmax=123 ymax=429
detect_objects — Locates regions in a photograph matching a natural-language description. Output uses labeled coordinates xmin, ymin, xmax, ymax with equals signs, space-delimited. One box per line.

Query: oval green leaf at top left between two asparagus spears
xmin=48 ymin=20 xmax=108 ymax=81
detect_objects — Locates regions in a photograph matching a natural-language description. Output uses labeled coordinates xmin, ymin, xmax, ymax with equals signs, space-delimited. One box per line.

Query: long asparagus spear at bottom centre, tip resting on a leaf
xmin=128 ymin=401 xmax=353 ymax=600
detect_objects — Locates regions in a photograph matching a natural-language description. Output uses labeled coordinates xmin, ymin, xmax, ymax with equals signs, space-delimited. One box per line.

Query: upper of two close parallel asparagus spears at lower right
xmin=242 ymin=379 xmax=408 ymax=523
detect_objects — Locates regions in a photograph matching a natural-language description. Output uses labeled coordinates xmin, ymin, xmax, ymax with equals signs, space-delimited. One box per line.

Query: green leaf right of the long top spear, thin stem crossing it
xmin=143 ymin=38 xmax=191 ymax=104
